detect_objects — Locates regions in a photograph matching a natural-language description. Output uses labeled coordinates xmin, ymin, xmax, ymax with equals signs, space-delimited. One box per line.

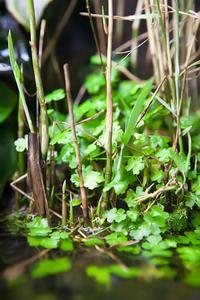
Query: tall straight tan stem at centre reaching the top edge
xmin=102 ymin=0 xmax=113 ymax=208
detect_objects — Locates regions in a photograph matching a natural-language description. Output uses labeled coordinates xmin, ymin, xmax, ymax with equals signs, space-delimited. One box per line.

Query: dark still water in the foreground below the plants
xmin=0 ymin=221 xmax=200 ymax=300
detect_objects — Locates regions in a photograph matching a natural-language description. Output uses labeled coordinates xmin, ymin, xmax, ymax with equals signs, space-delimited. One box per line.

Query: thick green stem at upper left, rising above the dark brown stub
xmin=28 ymin=0 xmax=49 ymax=158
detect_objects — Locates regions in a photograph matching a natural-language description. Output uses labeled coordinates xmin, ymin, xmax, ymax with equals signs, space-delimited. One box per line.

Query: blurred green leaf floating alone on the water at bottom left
xmin=31 ymin=257 xmax=71 ymax=278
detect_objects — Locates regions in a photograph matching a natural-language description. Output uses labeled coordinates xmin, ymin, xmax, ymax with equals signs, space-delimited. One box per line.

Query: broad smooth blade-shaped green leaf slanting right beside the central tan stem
xmin=123 ymin=81 xmax=152 ymax=145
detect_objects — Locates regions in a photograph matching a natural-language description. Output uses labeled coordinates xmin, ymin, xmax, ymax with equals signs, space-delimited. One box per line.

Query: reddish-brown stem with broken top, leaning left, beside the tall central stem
xmin=64 ymin=64 xmax=88 ymax=223
